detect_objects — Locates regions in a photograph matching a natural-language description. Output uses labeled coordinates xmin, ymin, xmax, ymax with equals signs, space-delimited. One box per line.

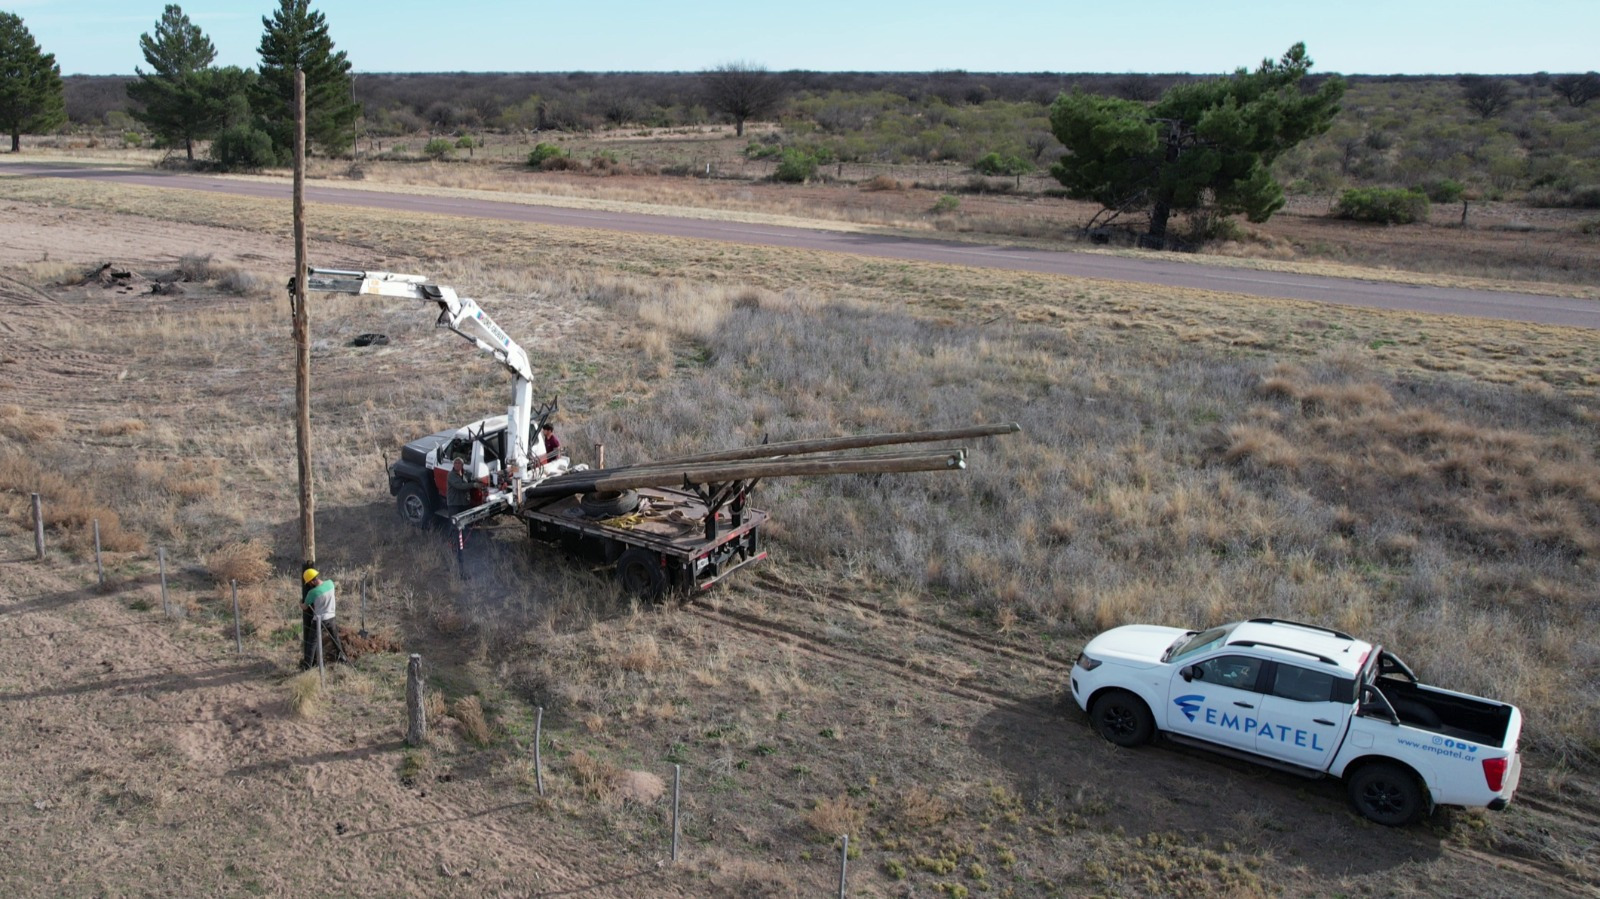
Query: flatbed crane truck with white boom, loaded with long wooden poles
xmin=306 ymin=267 xmax=1019 ymax=598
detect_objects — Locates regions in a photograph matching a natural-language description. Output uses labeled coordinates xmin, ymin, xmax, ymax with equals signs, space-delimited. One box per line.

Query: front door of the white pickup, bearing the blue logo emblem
xmin=1163 ymin=653 xmax=1266 ymax=752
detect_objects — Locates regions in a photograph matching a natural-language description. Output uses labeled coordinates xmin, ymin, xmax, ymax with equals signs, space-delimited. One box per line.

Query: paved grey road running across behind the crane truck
xmin=12 ymin=163 xmax=1600 ymax=330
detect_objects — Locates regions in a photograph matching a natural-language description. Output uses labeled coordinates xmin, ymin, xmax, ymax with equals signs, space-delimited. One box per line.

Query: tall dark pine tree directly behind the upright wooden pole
xmin=250 ymin=0 xmax=360 ymax=158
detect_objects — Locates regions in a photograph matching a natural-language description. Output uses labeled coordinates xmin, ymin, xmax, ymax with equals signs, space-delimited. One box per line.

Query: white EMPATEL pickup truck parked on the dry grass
xmin=1072 ymin=617 xmax=1522 ymax=827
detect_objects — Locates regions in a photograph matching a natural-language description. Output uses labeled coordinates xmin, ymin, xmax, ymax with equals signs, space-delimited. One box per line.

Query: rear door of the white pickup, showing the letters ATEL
xmin=1254 ymin=662 xmax=1355 ymax=771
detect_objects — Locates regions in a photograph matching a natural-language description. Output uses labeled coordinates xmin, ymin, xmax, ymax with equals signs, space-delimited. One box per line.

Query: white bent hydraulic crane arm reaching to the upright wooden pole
xmin=306 ymin=269 xmax=538 ymax=483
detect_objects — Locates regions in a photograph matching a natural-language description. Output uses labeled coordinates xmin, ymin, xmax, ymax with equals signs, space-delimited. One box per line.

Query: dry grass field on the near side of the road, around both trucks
xmin=0 ymin=155 xmax=1600 ymax=896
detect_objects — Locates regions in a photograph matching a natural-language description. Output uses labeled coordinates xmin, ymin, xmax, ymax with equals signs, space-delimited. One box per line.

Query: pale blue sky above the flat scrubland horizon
xmin=12 ymin=0 xmax=1600 ymax=75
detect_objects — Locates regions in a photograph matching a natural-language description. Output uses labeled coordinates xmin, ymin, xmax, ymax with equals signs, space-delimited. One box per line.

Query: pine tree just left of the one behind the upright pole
xmin=128 ymin=3 xmax=229 ymax=162
